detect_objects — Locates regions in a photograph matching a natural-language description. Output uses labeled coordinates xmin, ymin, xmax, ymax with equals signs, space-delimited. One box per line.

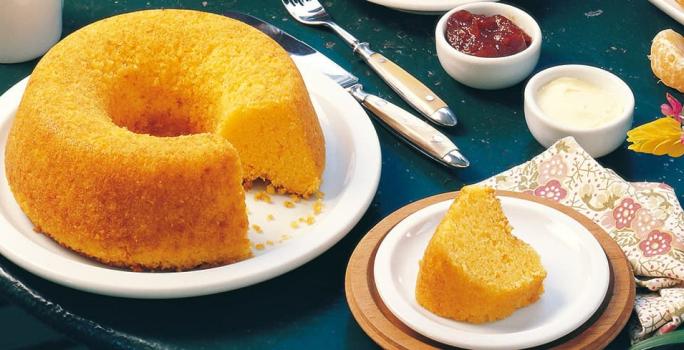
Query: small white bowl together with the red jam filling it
xmin=435 ymin=2 xmax=542 ymax=90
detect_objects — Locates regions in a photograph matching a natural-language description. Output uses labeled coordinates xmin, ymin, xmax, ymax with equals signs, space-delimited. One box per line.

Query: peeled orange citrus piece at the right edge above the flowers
xmin=649 ymin=29 xmax=684 ymax=92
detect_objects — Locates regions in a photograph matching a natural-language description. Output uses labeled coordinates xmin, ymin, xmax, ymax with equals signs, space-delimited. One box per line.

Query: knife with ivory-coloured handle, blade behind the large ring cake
xmin=224 ymin=12 xmax=470 ymax=168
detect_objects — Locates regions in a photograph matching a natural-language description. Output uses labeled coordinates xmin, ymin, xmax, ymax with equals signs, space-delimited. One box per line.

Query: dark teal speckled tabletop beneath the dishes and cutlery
xmin=0 ymin=0 xmax=684 ymax=349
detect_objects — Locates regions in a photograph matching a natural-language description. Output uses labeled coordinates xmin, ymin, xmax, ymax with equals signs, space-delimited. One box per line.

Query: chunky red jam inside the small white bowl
xmin=446 ymin=10 xmax=532 ymax=57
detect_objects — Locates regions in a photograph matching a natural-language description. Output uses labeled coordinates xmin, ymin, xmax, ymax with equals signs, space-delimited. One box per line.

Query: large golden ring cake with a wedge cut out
xmin=5 ymin=10 xmax=325 ymax=270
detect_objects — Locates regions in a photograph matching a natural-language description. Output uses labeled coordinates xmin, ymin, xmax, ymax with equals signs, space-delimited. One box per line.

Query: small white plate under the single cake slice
xmin=374 ymin=196 xmax=609 ymax=349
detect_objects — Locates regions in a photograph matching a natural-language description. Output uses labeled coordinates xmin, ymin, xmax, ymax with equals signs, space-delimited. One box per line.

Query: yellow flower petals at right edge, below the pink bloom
xmin=627 ymin=117 xmax=684 ymax=157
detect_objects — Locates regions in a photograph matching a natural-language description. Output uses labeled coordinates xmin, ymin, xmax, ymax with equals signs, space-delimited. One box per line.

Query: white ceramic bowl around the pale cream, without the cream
xmin=525 ymin=64 xmax=634 ymax=158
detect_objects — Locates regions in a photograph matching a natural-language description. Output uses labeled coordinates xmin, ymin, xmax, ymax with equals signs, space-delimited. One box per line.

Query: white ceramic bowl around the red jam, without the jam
xmin=435 ymin=2 xmax=542 ymax=90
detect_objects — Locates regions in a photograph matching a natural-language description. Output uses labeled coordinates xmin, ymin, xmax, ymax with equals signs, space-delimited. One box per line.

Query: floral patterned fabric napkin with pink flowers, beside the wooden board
xmin=482 ymin=137 xmax=684 ymax=341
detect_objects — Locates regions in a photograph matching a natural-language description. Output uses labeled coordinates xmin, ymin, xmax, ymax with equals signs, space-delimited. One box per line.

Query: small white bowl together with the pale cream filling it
xmin=525 ymin=65 xmax=634 ymax=157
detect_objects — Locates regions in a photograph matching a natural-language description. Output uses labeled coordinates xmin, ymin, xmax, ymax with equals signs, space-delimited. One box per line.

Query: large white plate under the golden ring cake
xmin=0 ymin=67 xmax=381 ymax=298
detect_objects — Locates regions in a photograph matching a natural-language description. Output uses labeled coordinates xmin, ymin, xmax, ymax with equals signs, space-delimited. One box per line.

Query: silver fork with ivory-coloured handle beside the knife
xmin=282 ymin=0 xmax=458 ymax=126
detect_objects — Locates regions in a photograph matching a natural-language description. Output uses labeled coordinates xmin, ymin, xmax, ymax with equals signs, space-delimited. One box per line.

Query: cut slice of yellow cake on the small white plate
xmin=416 ymin=186 xmax=546 ymax=323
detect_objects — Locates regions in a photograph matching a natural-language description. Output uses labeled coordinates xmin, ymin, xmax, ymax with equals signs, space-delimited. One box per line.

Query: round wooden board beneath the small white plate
xmin=345 ymin=191 xmax=636 ymax=350
